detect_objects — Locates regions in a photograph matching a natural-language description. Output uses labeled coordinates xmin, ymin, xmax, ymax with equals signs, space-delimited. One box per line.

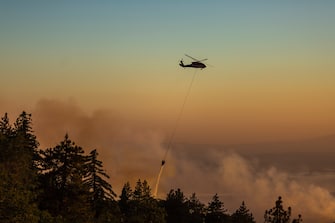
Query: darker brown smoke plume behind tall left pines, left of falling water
xmin=33 ymin=99 xmax=169 ymax=193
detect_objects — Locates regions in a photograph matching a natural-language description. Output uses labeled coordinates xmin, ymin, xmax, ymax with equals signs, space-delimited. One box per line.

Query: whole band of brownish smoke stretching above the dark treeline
xmin=32 ymin=99 xmax=335 ymax=222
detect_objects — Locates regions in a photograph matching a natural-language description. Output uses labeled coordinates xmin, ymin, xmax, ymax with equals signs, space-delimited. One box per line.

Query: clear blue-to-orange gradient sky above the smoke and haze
xmin=0 ymin=1 xmax=335 ymax=142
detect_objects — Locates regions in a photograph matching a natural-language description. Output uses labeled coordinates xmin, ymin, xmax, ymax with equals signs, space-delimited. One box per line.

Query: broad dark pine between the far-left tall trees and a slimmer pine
xmin=40 ymin=134 xmax=91 ymax=222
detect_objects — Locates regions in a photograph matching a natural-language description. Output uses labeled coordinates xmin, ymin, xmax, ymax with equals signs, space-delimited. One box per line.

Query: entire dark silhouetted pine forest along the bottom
xmin=0 ymin=112 xmax=302 ymax=223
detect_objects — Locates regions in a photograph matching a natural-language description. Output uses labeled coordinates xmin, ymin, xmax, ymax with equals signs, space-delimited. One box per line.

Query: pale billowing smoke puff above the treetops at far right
xmin=220 ymin=154 xmax=335 ymax=222
